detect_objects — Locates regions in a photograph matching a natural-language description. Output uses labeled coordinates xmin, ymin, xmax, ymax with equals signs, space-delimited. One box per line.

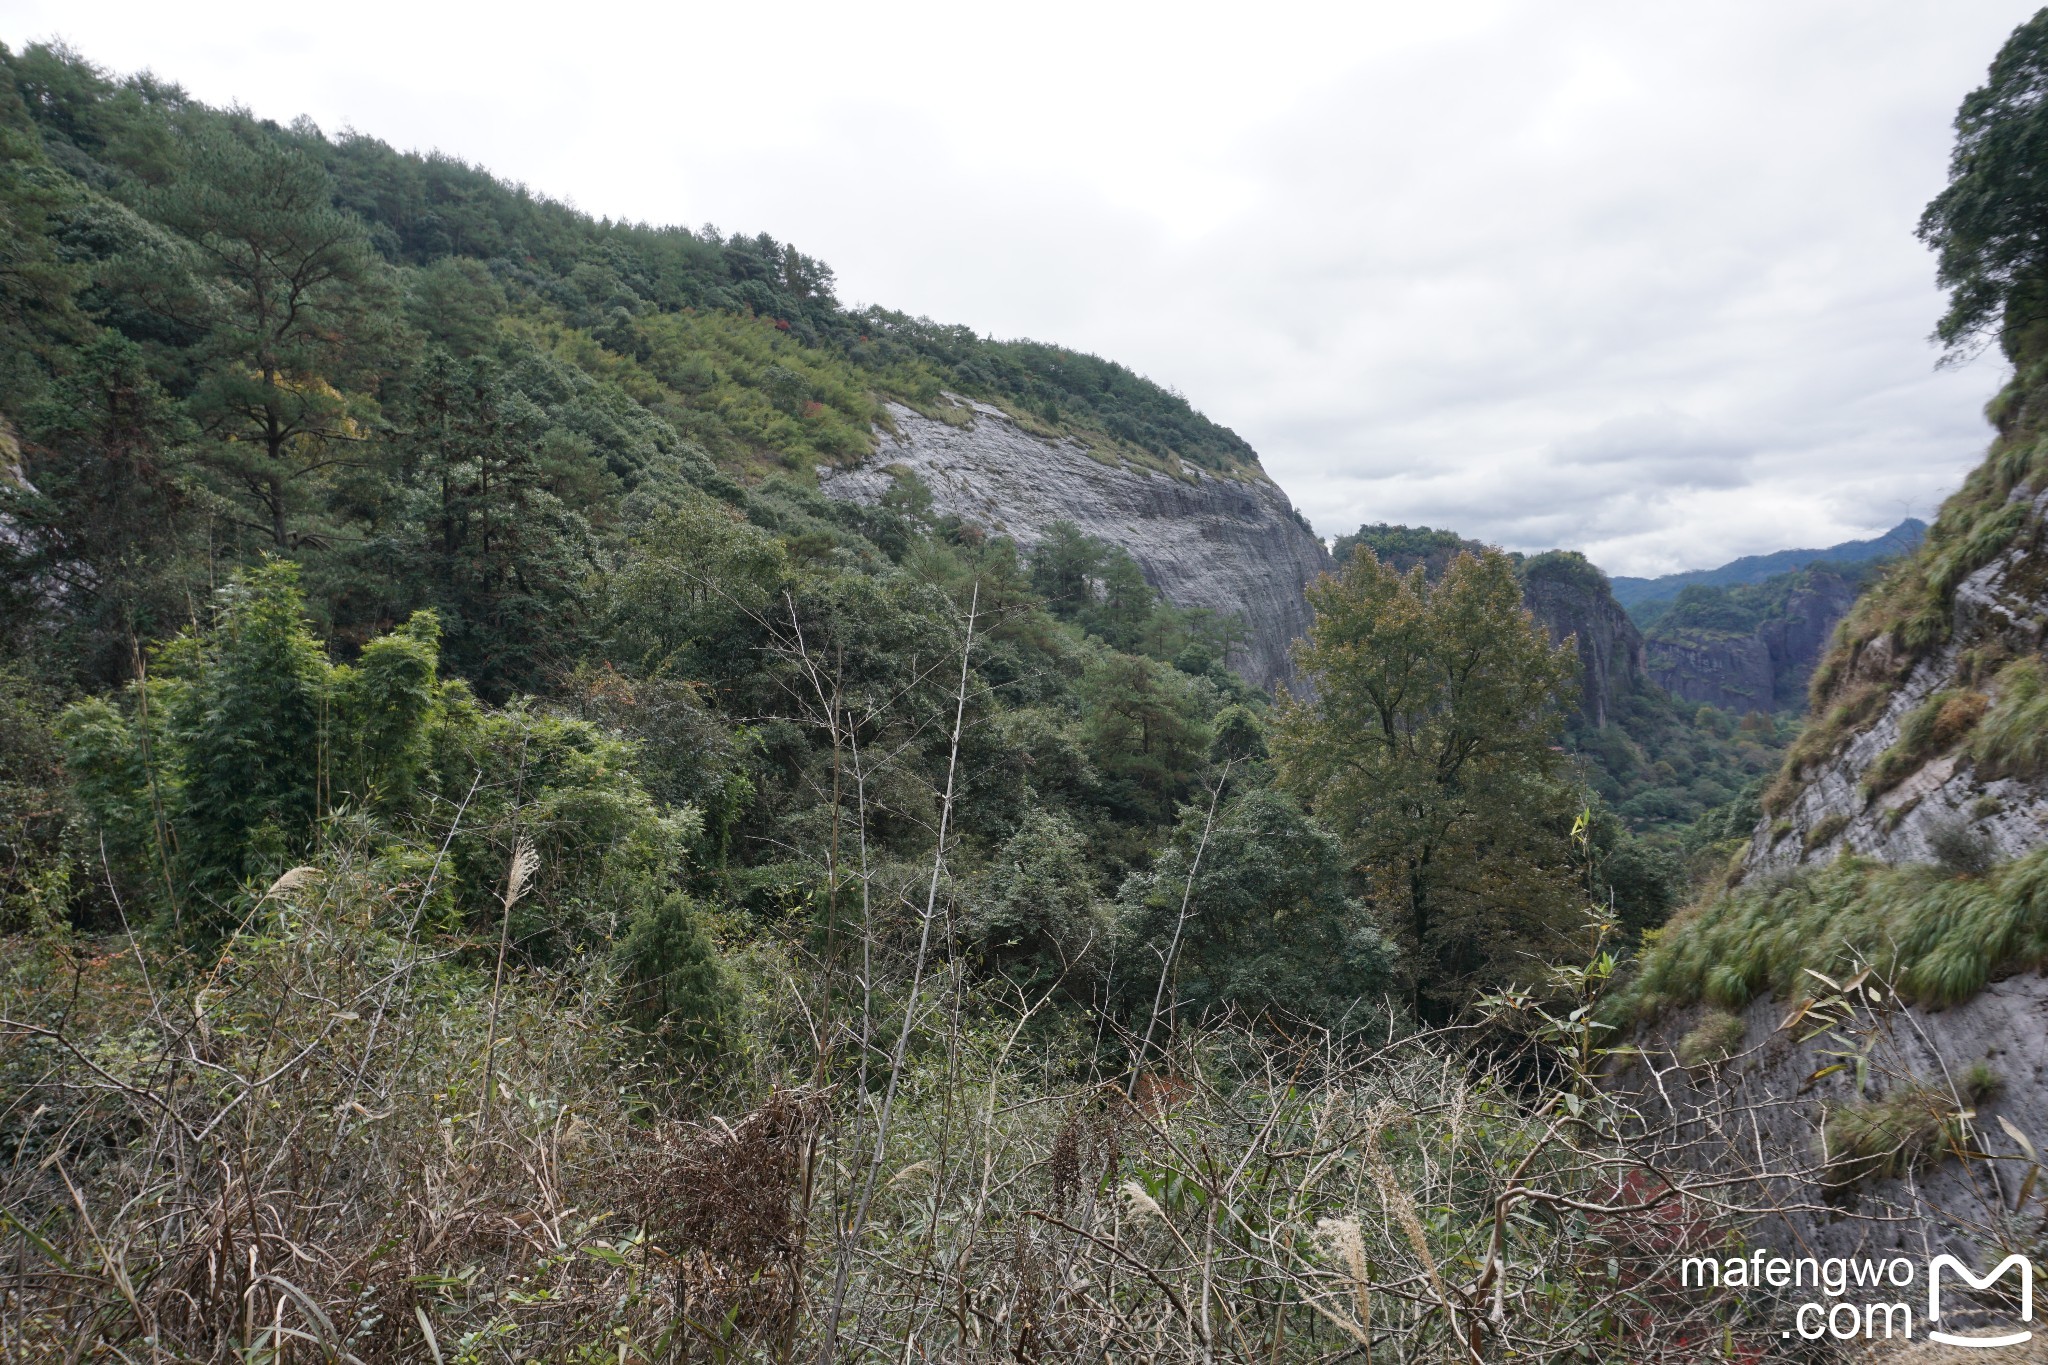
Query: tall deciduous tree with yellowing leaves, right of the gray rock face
xmin=1274 ymin=551 xmax=1579 ymax=1019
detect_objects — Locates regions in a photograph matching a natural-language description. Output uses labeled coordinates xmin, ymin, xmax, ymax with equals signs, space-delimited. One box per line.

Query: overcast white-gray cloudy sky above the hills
xmin=12 ymin=0 xmax=2032 ymax=573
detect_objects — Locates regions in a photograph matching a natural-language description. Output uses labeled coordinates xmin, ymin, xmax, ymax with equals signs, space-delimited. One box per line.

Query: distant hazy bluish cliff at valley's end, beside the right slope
xmin=1642 ymin=567 xmax=1862 ymax=714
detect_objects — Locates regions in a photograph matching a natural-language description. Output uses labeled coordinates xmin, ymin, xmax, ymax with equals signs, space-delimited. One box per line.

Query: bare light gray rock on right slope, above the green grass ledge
xmin=1743 ymin=485 xmax=2048 ymax=876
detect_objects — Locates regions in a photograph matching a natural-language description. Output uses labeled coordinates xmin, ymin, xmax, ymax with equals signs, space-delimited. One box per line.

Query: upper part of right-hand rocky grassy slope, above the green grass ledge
xmin=1745 ymin=413 xmax=2048 ymax=874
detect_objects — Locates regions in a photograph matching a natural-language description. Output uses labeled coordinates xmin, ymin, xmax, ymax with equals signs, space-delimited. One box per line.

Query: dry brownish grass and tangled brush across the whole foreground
xmin=0 ymin=857 xmax=1794 ymax=1365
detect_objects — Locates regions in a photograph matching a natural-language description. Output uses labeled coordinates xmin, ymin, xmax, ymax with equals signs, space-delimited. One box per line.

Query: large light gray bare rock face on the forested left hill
xmin=817 ymin=403 xmax=1331 ymax=686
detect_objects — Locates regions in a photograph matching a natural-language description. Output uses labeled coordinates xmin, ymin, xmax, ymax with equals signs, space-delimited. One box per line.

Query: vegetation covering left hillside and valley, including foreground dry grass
xmin=0 ymin=24 xmax=2039 ymax=1365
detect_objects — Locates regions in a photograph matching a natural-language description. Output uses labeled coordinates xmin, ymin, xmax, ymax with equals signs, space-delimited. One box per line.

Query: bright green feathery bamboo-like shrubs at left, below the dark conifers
xmin=59 ymin=563 xmax=700 ymax=960
